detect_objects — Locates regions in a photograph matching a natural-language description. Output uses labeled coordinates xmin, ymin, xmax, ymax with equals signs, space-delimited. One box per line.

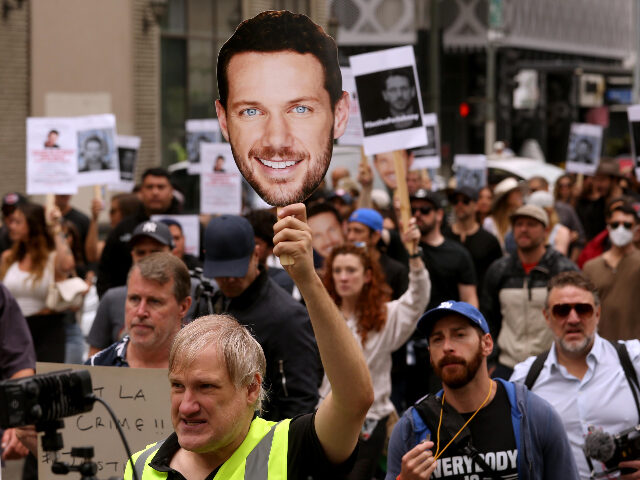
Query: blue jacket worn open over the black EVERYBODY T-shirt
xmin=386 ymin=379 xmax=580 ymax=480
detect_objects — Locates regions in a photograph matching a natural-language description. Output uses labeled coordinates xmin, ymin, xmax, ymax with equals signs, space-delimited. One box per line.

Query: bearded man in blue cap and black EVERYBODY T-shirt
xmin=386 ymin=300 xmax=579 ymax=480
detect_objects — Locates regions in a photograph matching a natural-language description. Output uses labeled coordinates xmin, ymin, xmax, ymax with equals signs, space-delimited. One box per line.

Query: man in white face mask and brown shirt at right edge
xmin=584 ymin=202 xmax=640 ymax=340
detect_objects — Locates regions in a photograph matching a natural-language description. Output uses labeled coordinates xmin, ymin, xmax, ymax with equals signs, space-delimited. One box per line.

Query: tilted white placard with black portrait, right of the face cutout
xmin=349 ymin=46 xmax=427 ymax=155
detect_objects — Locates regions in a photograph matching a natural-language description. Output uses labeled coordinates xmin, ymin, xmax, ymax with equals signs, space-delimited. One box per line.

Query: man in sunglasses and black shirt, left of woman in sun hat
xmin=443 ymin=186 xmax=502 ymax=289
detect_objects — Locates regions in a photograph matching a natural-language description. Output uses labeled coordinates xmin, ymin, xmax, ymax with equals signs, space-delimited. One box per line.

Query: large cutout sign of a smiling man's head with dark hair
xmin=216 ymin=11 xmax=349 ymax=206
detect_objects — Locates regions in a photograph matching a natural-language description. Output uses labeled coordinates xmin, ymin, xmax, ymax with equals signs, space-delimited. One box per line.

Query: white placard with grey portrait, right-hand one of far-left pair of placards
xmin=75 ymin=114 xmax=120 ymax=186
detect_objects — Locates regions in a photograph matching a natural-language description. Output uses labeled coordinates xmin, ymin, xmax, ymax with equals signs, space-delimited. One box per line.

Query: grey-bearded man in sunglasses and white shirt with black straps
xmin=511 ymin=272 xmax=640 ymax=480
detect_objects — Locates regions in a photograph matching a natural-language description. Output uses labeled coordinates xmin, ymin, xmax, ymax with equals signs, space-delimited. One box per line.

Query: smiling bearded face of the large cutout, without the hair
xmin=216 ymin=50 xmax=349 ymax=206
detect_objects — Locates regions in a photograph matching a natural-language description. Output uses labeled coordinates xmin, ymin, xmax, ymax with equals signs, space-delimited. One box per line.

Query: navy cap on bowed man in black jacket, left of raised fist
xmin=203 ymin=215 xmax=256 ymax=278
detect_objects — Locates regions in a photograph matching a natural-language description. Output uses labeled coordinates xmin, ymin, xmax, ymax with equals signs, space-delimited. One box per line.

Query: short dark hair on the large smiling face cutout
xmin=217 ymin=10 xmax=342 ymax=108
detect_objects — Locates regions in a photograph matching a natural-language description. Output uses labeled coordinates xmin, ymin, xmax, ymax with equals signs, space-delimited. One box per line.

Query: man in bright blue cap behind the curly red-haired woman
xmin=347 ymin=208 xmax=409 ymax=300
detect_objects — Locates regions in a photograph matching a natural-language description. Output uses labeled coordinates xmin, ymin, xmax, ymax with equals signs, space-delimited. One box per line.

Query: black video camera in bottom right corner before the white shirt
xmin=583 ymin=425 xmax=640 ymax=478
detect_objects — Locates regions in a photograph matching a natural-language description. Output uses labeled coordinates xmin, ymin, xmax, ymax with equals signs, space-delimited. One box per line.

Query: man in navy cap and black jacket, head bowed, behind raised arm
xmin=204 ymin=215 xmax=322 ymax=421
